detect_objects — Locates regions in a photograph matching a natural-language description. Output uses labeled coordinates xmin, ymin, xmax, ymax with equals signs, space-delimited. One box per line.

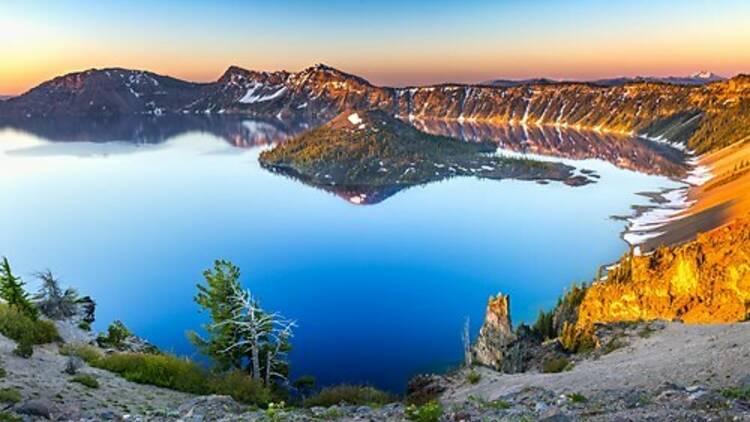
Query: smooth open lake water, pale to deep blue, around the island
xmin=0 ymin=117 xmax=675 ymax=391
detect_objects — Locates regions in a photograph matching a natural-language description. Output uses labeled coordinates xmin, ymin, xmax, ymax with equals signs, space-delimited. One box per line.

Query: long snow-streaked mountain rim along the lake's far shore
xmin=0 ymin=65 xmax=750 ymax=152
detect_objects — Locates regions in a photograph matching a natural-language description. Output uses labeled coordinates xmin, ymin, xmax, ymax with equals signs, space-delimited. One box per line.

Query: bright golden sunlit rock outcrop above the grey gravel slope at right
xmin=576 ymin=216 xmax=750 ymax=330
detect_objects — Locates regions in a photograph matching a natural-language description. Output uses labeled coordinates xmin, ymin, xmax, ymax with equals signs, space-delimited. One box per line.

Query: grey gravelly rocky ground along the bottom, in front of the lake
xmin=0 ymin=322 xmax=750 ymax=421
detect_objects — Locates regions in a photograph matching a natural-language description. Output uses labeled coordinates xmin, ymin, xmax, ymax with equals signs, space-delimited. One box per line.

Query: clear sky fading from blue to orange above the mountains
xmin=0 ymin=0 xmax=750 ymax=95
